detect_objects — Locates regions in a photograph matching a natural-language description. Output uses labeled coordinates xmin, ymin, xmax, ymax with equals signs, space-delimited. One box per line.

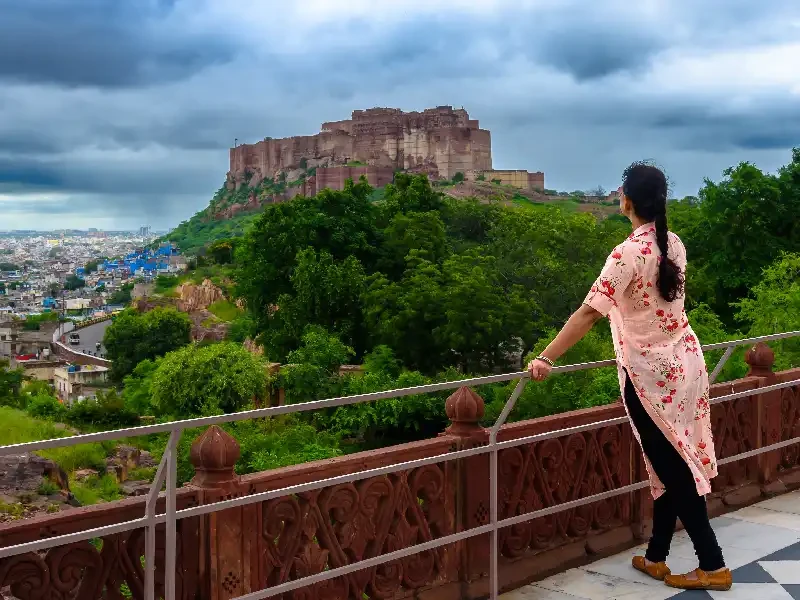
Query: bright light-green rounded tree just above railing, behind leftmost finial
xmin=151 ymin=342 xmax=267 ymax=417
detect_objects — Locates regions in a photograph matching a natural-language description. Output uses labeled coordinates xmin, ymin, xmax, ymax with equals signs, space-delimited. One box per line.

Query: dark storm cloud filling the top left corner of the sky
xmin=0 ymin=0 xmax=234 ymax=88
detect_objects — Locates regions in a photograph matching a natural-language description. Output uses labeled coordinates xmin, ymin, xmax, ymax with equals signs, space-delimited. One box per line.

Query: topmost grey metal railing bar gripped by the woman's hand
xmin=0 ymin=331 xmax=800 ymax=456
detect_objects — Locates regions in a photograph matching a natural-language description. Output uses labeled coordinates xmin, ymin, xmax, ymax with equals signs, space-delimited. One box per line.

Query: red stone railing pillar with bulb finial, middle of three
xmin=445 ymin=387 xmax=489 ymax=598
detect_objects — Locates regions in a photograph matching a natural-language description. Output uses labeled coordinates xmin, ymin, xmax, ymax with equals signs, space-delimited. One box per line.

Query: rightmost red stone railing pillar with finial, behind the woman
xmin=744 ymin=342 xmax=786 ymax=493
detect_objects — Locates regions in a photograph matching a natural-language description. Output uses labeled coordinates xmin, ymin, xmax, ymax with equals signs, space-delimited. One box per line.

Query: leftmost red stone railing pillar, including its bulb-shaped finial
xmin=189 ymin=425 xmax=252 ymax=600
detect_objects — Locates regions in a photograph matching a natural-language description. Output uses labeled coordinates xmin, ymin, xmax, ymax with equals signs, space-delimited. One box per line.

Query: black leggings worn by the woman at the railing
xmin=625 ymin=372 xmax=725 ymax=571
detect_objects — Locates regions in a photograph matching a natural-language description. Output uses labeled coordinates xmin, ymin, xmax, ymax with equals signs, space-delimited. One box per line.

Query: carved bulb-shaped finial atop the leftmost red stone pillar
xmin=189 ymin=425 xmax=241 ymax=488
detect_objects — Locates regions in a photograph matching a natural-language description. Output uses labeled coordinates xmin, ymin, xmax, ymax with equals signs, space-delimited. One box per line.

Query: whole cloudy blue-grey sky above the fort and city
xmin=0 ymin=0 xmax=800 ymax=230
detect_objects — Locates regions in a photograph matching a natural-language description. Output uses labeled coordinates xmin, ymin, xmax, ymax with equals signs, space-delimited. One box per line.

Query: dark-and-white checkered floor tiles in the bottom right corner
xmin=672 ymin=543 xmax=800 ymax=600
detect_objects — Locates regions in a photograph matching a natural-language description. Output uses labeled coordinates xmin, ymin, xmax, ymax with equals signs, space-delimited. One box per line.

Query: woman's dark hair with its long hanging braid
xmin=622 ymin=162 xmax=684 ymax=302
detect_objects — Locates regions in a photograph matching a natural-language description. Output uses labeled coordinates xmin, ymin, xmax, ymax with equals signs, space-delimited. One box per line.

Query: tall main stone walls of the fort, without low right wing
xmin=228 ymin=106 xmax=492 ymax=187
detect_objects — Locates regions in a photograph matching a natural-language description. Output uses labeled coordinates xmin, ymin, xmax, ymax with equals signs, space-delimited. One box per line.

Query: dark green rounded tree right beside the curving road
xmin=103 ymin=308 xmax=192 ymax=382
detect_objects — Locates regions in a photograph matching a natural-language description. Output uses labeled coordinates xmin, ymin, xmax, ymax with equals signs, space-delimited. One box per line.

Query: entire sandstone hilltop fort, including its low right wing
xmin=227 ymin=106 xmax=544 ymax=194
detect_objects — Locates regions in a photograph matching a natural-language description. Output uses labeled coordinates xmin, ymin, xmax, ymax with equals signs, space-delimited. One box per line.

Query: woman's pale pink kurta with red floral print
xmin=584 ymin=223 xmax=717 ymax=498
